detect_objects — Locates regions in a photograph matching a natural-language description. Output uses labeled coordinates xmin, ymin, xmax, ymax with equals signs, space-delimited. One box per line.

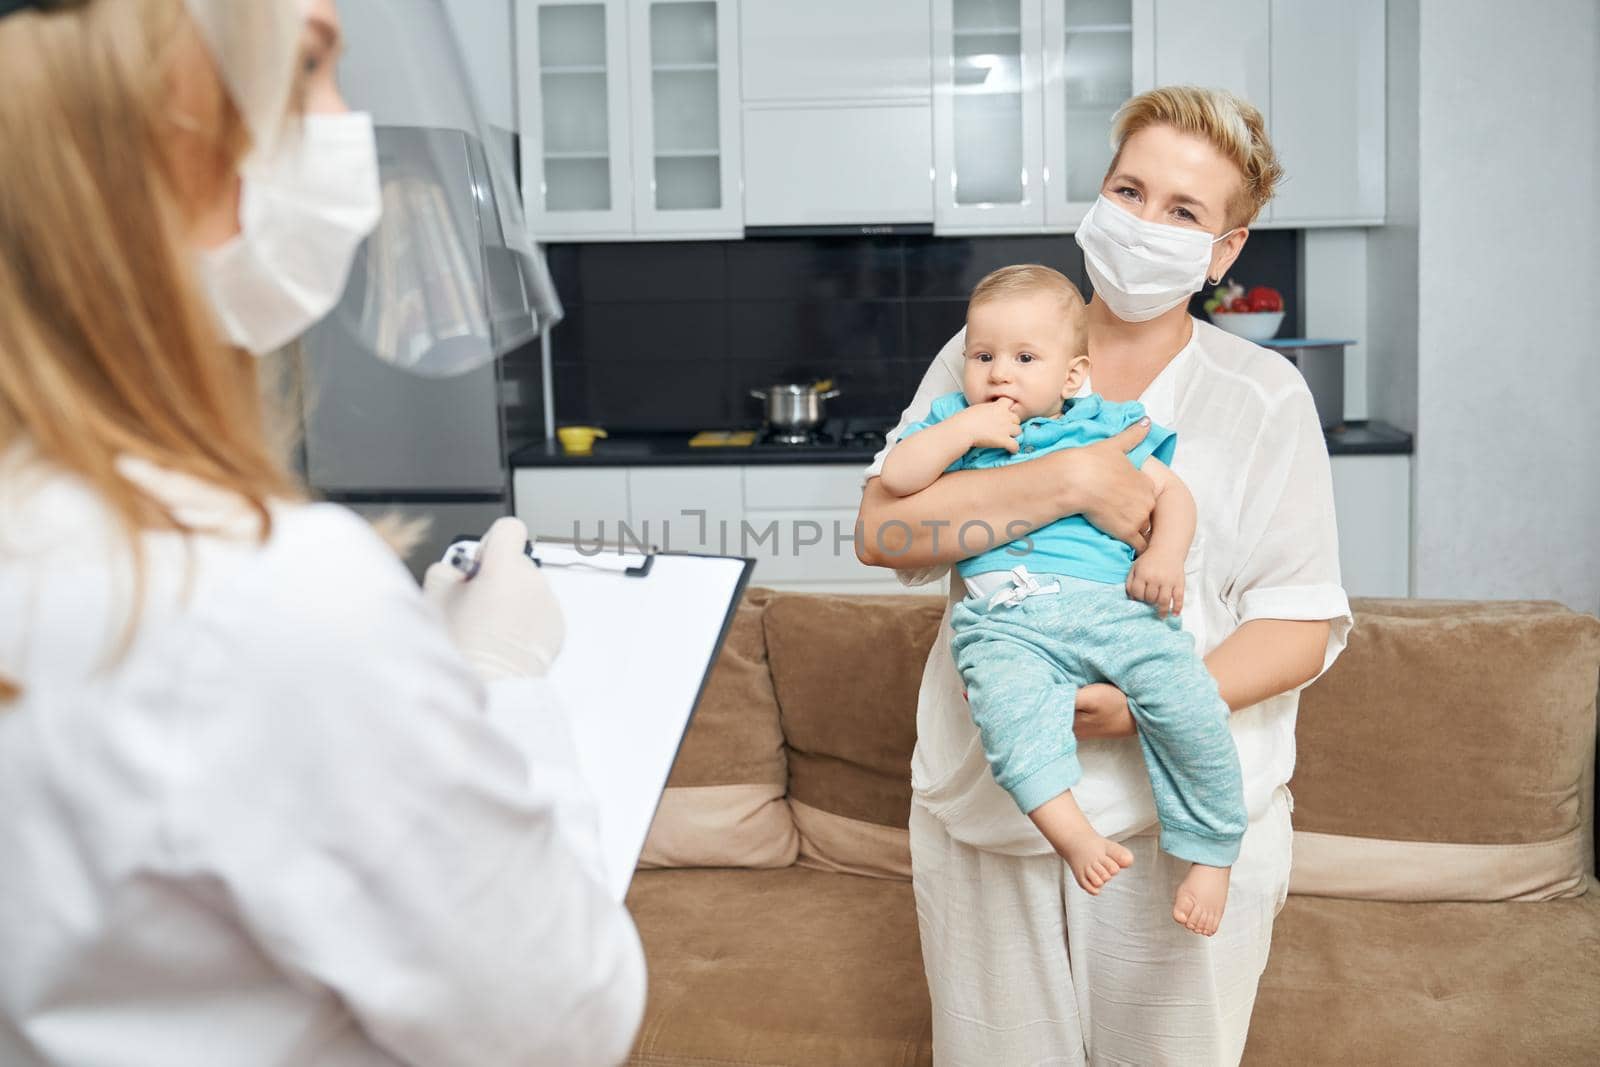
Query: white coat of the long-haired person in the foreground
xmin=0 ymin=458 xmax=645 ymax=1067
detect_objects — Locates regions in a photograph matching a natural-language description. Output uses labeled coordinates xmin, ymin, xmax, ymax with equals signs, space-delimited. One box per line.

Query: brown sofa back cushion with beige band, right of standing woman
xmin=1290 ymin=600 xmax=1600 ymax=901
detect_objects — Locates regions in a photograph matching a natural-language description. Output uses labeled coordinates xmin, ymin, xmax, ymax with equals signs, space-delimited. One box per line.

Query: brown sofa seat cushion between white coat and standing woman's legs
xmin=627 ymin=867 xmax=933 ymax=1067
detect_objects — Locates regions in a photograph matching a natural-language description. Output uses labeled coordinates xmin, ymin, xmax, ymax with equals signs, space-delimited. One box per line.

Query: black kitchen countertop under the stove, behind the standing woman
xmin=510 ymin=419 xmax=1411 ymax=467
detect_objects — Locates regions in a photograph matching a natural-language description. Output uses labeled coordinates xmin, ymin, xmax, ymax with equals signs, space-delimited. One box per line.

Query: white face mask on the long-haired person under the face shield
xmin=200 ymin=112 xmax=382 ymax=355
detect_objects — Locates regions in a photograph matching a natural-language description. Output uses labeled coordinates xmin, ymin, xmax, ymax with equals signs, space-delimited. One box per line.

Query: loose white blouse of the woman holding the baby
xmin=866 ymin=320 xmax=1352 ymax=856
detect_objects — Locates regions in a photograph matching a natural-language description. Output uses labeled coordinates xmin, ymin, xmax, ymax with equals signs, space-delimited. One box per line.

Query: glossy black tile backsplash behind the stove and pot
xmin=504 ymin=230 xmax=1304 ymax=438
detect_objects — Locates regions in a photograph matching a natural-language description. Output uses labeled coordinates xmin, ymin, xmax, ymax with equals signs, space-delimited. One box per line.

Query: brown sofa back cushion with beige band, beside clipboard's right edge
xmin=640 ymin=589 xmax=800 ymax=869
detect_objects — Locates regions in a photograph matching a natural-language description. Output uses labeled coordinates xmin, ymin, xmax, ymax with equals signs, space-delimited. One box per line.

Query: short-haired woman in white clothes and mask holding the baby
xmin=859 ymin=86 xmax=1350 ymax=1065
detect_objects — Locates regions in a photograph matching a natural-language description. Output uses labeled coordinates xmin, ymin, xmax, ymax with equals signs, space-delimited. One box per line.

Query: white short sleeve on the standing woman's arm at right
xmin=1224 ymin=389 xmax=1352 ymax=685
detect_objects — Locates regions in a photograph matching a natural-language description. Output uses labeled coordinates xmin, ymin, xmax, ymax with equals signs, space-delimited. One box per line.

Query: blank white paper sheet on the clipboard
xmin=534 ymin=541 xmax=754 ymax=901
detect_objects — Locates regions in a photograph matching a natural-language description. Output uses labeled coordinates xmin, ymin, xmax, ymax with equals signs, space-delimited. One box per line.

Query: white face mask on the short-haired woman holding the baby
xmin=1077 ymin=197 xmax=1235 ymax=322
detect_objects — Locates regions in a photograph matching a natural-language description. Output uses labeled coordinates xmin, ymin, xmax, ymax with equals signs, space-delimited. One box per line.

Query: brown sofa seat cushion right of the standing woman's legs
xmin=1243 ymin=895 xmax=1600 ymax=1067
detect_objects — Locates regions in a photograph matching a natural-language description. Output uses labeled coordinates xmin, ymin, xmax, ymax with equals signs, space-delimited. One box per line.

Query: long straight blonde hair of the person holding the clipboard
xmin=0 ymin=0 xmax=299 ymax=668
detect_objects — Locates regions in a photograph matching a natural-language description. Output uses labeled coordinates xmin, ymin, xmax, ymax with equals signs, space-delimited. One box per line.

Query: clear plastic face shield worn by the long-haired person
xmin=186 ymin=0 xmax=562 ymax=378
